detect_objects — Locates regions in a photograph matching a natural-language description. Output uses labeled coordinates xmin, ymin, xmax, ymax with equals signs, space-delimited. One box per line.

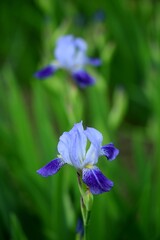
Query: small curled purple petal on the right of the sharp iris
xmin=101 ymin=143 xmax=119 ymax=161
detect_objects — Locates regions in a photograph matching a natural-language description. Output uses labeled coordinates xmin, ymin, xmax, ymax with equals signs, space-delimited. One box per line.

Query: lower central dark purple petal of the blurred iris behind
xmin=72 ymin=70 xmax=95 ymax=88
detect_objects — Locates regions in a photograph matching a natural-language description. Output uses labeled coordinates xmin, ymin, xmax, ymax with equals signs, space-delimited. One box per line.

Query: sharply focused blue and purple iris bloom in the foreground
xmin=37 ymin=122 xmax=119 ymax=194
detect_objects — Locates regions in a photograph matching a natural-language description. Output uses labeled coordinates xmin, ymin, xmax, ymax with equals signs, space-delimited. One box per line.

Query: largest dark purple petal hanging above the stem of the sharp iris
xmin=82 ymin=167 xmax=113 ymax=194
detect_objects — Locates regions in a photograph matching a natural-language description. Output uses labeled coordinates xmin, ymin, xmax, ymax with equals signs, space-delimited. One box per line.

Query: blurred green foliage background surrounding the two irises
xmin=0 ymin=0 xmax=160 ymax=240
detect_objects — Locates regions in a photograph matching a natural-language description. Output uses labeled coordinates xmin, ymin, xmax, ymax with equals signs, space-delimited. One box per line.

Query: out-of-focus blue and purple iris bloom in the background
xmin=35 ymin=35 xmax=101 ymax=87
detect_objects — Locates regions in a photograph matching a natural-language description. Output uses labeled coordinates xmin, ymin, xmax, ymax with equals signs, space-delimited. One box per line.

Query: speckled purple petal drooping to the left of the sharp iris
xmin=37 ymin=158 xmax=65 ymax=177
